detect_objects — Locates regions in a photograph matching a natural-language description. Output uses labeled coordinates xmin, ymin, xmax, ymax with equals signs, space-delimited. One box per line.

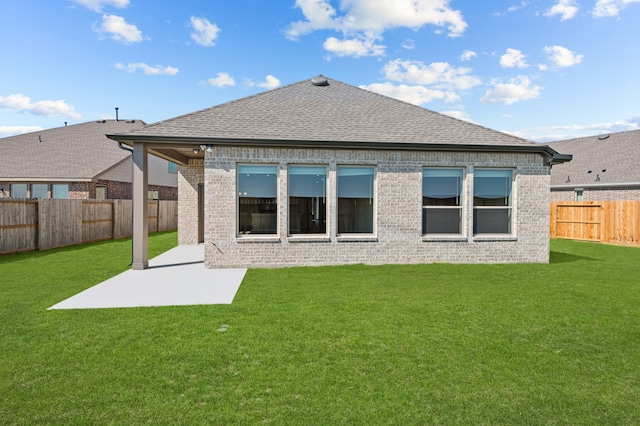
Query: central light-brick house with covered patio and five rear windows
xmin=109 ymin=76 xmax=571 ymax=269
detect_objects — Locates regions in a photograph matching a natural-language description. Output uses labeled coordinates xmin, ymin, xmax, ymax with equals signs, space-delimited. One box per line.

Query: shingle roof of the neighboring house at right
xmin=548 ymin=130 xmax=640 ymax=188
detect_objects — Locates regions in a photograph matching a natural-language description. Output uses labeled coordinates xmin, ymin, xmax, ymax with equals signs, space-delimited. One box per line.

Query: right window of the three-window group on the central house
xmin=338 ymin=166 xmax=374 ymax=234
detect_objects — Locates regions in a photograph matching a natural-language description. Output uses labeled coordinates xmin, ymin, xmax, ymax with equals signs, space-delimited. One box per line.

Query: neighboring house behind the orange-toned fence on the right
xmin=549 ymin=130 xmax=640 ymax=201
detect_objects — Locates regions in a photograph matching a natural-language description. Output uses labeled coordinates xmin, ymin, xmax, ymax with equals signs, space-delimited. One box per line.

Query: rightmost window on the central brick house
xmin=473 ymin=169 xmax=513 ymax=234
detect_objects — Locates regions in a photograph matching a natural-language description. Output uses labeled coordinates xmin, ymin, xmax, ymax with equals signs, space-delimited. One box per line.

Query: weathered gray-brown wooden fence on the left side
xmin=0 ymin=198 xmax=178 ymax=254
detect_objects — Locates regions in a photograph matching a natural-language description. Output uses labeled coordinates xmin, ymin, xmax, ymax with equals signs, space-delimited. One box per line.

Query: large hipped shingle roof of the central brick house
xmin=110 ymin=76 xmax=570 ymax=165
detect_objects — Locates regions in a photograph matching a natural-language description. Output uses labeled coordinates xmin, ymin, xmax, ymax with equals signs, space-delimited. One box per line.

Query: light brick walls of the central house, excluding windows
xmin=179 ymin=147 xmax=549 ymax=268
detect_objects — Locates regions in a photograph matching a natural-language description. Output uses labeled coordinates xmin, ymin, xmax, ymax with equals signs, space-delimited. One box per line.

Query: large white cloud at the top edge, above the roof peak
xmin=285 ymin=0 xmax=467 ymax=56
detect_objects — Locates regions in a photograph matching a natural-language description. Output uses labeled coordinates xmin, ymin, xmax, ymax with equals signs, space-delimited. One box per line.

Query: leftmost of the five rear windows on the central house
xmin=237 ymin=165 xmax=278 ymax=234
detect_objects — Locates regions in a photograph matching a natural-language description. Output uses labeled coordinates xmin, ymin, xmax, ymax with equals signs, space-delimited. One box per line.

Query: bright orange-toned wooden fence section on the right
xmin=550 ymin=201 xmax=640 ymax=245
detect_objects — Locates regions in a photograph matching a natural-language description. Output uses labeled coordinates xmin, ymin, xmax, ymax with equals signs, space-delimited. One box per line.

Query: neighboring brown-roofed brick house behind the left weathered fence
xmin=0 ymin=120 xmax=178 ymax=200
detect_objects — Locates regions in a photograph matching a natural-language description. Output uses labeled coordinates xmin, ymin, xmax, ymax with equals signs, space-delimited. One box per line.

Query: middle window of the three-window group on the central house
xmin=289 ymin=166 xmax=327 ymax=234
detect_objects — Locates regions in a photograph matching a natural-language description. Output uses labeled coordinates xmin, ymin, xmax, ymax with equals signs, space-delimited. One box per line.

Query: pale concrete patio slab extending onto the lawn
xmin=49 ymin=245 xmax=247 ymax=309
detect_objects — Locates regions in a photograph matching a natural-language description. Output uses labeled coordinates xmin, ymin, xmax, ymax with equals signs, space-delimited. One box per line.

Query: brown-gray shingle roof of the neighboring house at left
xmin=0 ymin=120 xmax=145 ymax=180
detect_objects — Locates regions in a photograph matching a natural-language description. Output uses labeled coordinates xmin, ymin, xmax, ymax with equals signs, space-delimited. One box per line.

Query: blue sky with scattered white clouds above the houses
xmin=0 ymin=0 xmax=640 ymax=142
